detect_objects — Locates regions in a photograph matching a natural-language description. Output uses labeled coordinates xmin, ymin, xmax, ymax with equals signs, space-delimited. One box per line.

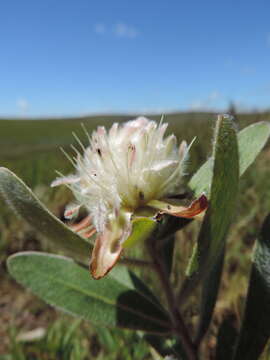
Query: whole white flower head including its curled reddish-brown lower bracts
xmin=52 ymin=117 xmax=207 ymax=279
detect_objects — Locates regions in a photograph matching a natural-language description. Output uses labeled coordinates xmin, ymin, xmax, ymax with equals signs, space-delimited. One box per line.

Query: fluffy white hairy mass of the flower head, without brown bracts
xmin=52 ymin=117 xmax=188 ymax=232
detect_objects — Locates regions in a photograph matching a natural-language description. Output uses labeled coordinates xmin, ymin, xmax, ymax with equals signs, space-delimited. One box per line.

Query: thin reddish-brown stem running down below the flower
xmin=147 ymin=238 xmax=198 ymax=360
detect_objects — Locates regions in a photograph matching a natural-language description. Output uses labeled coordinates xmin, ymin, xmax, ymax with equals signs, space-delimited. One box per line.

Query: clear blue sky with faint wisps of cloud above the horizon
xmin=0 ymin=0 xmax=270 ymax=116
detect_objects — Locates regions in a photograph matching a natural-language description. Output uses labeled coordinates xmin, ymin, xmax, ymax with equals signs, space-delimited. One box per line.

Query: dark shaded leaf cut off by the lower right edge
xmin=234 ymin=214 xmax=270 ymax=360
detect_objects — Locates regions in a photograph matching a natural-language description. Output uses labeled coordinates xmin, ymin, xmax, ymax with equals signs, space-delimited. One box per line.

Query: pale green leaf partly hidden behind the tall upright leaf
xmin=189 ymin=121 xmax=270 ymax=197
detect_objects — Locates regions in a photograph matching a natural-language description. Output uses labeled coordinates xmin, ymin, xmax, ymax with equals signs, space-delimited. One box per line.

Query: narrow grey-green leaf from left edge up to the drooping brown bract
xmin=0 ymin=168 xmax=92 ymax=260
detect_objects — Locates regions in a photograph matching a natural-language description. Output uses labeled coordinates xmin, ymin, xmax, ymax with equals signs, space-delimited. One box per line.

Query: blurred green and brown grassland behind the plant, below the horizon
xmin=0 ymin=113 xmax=270 ymax=360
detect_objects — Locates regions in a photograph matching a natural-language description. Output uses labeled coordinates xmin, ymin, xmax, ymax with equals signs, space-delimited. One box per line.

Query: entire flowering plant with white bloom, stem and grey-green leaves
xmin=0 ymin=115 xmax=270 ymax=360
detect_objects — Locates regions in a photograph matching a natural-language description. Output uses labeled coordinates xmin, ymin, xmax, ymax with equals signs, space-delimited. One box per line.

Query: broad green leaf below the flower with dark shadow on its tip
xmin=8 ymin=252 xmax=170 ymax=334
